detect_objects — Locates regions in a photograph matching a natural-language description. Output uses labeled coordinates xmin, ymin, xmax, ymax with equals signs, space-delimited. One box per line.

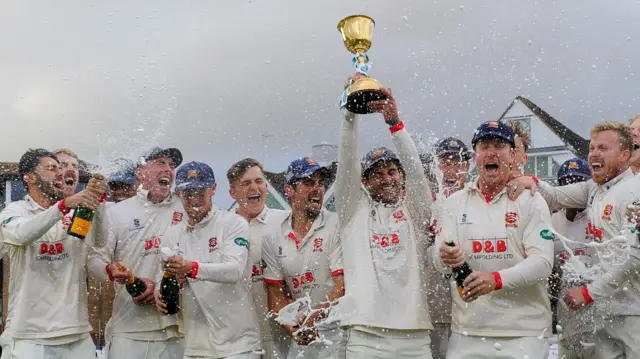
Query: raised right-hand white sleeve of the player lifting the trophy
xmin=391 ymin=128 xmax=433 ymax=229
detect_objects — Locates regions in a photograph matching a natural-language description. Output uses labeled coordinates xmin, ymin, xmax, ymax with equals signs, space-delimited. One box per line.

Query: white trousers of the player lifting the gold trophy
xmin=347 ymin=329 xmax=432 ymax=359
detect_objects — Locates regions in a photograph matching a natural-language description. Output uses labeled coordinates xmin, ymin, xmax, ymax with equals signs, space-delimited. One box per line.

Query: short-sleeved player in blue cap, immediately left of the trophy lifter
xmin=262 ymin=157 xmax=346 ymax=359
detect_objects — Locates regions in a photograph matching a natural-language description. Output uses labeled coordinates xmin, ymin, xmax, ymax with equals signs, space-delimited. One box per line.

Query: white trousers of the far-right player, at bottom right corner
xmin=595 ymin=315 xmax=640 ymax=359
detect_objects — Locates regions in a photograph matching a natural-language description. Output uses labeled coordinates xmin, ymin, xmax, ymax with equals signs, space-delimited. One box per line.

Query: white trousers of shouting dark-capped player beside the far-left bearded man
xmin=105 ymin=336 xmax=184 ymax=359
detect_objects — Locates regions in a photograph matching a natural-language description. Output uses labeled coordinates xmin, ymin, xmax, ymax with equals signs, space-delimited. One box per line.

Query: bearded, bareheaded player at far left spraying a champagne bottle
xmin=0 ymin=149 xmax=106 ymax=359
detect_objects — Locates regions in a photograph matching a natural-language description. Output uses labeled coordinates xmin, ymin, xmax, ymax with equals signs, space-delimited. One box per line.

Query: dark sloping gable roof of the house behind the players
xmin=499 ymin=96 xmax=589 ymax=158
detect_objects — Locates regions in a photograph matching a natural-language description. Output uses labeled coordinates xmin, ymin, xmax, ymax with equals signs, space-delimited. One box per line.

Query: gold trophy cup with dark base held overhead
xmin=338 ymin=15 xmax=387 ymax=114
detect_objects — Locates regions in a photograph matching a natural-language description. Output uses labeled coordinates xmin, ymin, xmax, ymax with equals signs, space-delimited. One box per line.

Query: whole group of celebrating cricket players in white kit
xmin=0 ymin=74 xmax=640 ymax=359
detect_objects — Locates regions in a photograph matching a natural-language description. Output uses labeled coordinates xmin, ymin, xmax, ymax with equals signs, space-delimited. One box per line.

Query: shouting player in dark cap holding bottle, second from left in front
xmin=89 ymin=147 xmax=184 ymax=359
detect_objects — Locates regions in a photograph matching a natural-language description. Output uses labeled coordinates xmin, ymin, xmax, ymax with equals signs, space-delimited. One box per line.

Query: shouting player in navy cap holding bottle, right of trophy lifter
xmin=433 ymin=121 xmax=553 ymax=359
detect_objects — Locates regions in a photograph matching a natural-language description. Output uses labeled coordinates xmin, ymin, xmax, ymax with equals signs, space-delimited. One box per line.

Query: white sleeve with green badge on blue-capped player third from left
xmin=194 ymin=215 xmax=249 ymax=284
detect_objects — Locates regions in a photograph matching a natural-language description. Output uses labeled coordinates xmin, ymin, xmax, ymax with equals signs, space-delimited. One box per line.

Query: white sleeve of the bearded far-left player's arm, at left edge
xmin=1 ymin=202 xmax=64 ymax=246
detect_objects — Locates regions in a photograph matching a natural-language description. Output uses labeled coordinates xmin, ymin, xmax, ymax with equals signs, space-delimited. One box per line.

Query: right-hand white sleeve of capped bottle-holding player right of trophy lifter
xmin=498 ymin=193 xmax=554 ymax=289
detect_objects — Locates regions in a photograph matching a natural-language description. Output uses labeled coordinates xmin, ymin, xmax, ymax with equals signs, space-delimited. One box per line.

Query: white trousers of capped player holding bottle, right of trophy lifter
xmin=447 ymin=333 xmax=549 ymax=359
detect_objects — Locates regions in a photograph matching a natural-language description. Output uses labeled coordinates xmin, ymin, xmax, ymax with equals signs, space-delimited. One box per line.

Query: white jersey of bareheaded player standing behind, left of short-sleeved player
xmin=242 ymin=206 xmax=288 ymax=342
